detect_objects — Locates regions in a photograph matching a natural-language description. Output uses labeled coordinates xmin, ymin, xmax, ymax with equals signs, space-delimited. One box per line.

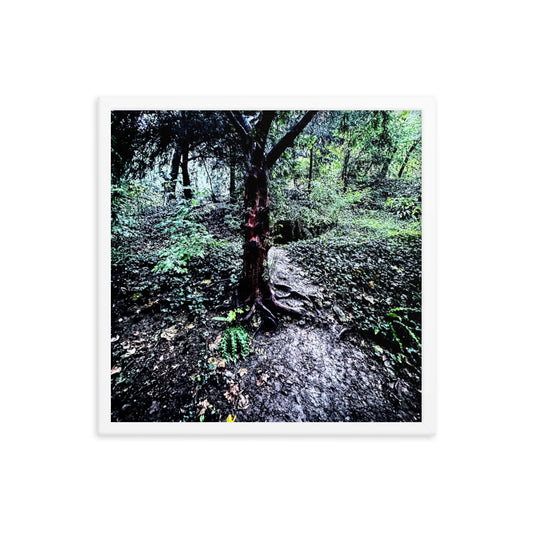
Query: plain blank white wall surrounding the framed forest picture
xmin=0 ymin=0 xmax=533 ymax=533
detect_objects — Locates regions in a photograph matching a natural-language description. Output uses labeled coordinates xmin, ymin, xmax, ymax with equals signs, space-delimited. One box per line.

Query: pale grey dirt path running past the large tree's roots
xmin=232 ymin=248 xmax=420 ymax=422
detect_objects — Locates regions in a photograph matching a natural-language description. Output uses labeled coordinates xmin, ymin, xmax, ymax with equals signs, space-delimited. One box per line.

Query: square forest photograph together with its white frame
xmin=98 ymin=96 xmax=436 ymax=435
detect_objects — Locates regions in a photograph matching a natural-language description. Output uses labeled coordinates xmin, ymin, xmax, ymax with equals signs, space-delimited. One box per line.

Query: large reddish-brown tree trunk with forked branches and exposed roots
xmin=227 ymin=111 xmax=316 ymax=323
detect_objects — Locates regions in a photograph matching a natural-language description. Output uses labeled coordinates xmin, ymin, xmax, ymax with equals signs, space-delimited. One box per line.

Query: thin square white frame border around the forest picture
xmin=97 ymin=95 xmax=437 ymax=436
